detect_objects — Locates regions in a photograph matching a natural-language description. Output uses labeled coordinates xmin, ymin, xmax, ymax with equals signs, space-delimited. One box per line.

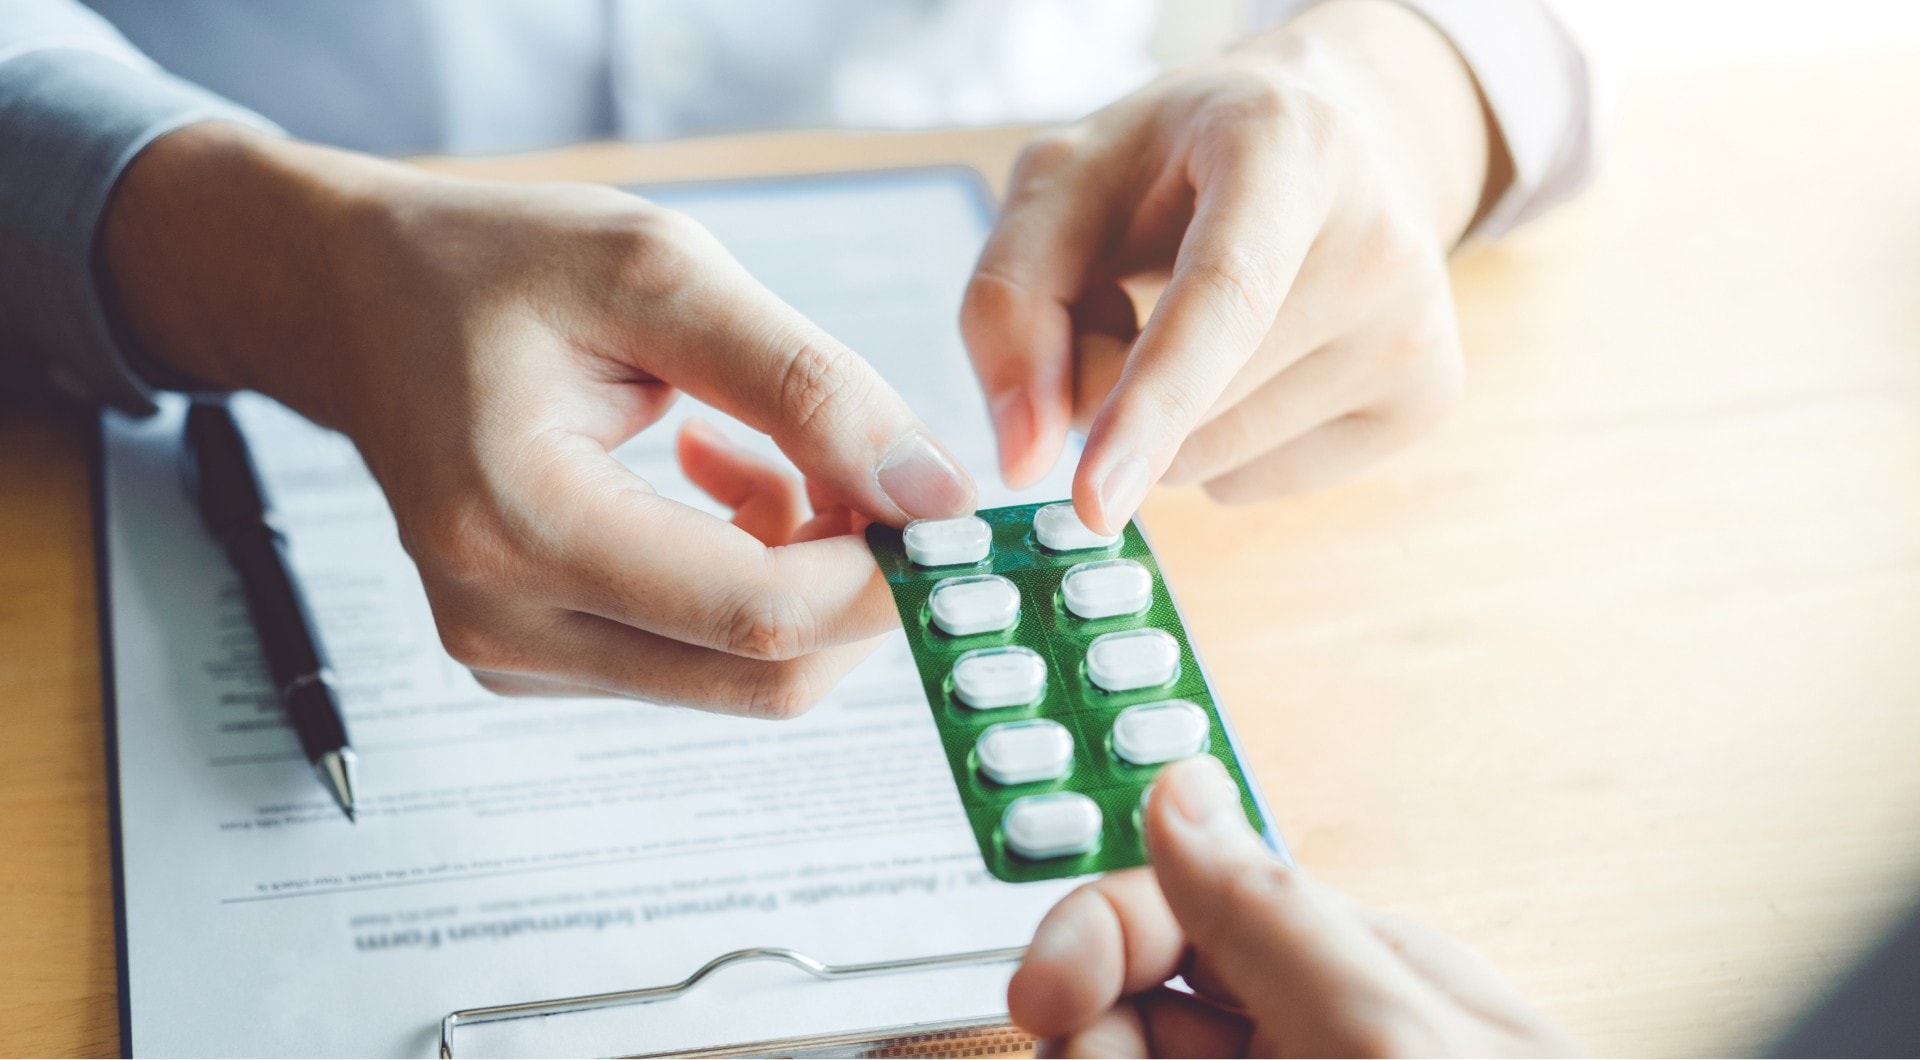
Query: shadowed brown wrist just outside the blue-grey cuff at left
xmin=100 ymin=123 xmax=396 ymax=422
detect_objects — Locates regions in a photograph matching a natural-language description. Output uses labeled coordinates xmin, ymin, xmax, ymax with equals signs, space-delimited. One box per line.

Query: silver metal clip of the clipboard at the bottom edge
xmin=440 ymin=947 xmax=1033 ymax=1060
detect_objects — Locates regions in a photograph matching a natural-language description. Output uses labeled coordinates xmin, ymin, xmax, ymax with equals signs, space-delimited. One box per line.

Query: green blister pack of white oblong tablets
xmin=866 ymin=501 xmax=1279 ymax=883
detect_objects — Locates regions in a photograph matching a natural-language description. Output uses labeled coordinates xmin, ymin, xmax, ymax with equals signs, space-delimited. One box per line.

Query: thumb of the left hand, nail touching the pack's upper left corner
xmin=648 ymin=233 xmax=973 ymax=524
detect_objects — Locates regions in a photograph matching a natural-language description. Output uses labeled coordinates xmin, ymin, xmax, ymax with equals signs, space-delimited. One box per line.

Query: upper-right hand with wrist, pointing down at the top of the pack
xmin=960 ymin=0 xmax=1503 ymax=532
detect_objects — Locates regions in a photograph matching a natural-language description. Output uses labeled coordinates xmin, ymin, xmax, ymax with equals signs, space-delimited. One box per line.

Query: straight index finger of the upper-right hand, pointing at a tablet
xmin=1073 ymin=146 xmax=1325 ymax=534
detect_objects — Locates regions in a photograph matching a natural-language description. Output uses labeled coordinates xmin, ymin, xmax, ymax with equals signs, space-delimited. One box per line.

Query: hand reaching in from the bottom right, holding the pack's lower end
xmin=1006 ymin=757 xmax=1578 ymax=1056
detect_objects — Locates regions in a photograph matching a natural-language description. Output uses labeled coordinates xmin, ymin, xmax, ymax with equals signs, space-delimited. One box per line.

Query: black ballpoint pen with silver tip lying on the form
xmin=186 ymin=401 xmax=355 ymax=820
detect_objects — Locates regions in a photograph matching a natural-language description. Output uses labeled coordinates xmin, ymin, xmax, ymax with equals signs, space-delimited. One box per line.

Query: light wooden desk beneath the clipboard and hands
xmin=0 ymin=54 xmax=1920 ymax=1054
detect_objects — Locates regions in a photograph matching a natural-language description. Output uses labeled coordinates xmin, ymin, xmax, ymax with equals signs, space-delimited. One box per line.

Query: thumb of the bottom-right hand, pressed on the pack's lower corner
xmin=1146 ymin=755 xmax=1394 ymax=1020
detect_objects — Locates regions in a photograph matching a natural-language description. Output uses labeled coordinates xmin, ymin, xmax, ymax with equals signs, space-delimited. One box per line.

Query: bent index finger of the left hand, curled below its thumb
xmin=534 ymin=438 xmax=899 ymax=659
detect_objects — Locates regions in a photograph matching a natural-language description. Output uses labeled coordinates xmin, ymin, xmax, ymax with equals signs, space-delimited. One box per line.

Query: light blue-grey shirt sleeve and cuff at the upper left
xmin=0 ymin=0 xmax=273 ymax=413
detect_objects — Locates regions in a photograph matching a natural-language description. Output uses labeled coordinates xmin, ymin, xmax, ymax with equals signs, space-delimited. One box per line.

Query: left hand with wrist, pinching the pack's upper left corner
xmin=104 ymin=125 xmax=973 ymax=716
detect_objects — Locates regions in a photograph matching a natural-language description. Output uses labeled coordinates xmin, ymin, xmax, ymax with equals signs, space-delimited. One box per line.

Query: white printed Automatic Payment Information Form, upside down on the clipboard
xmin=104 ymin=171 xmax=1090 ymax=1056
